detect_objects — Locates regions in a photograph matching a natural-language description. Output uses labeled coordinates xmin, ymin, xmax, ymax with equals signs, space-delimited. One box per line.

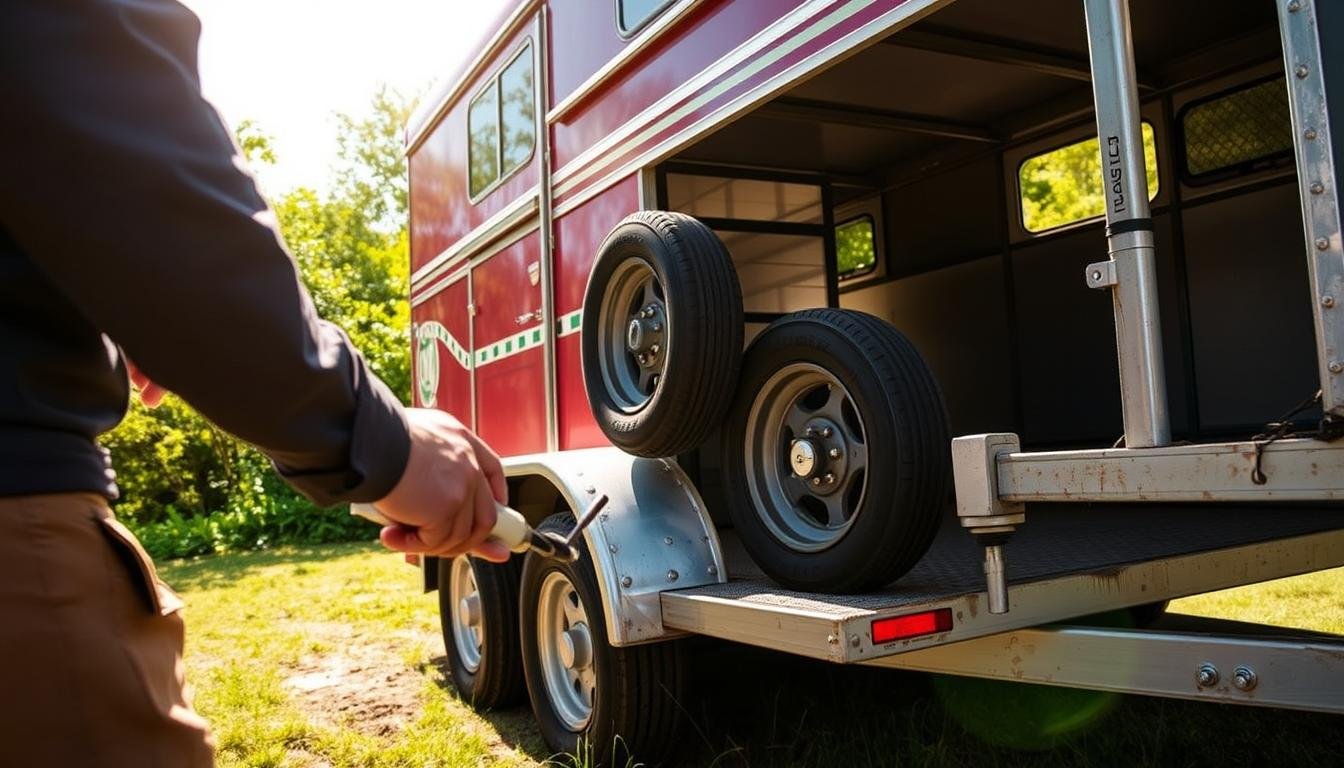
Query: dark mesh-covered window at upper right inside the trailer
xmin=1181 ymin=78 xmax=1293 ymax=178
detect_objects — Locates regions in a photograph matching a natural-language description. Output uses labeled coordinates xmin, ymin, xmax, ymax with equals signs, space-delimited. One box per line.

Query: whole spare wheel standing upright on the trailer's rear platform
xmin=723 ymin=309 xmax=952 ymax=592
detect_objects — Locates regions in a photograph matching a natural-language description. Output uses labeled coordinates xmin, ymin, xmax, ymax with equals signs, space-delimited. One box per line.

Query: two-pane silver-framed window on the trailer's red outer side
xmin=466 ymin=46 xmax=536 ymax=200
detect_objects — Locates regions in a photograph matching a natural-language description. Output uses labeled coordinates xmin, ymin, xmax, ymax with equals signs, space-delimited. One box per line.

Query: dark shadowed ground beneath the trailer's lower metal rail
xmin=672 ymin=642 xmax=1344 ymax=768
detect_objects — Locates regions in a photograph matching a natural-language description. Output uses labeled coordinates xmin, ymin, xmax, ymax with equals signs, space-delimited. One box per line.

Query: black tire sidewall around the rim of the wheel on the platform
xmin=723 ymin=317 xmax=913 ymax=588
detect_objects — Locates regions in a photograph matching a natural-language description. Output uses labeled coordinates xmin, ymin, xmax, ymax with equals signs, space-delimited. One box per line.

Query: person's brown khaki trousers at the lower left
xmin=0 ymin=494 xmax=214 ymax=768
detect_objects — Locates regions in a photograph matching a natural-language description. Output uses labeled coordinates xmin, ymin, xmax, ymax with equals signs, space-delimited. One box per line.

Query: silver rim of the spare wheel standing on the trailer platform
xmin=743 ymin=363 xmax=868 ymax=551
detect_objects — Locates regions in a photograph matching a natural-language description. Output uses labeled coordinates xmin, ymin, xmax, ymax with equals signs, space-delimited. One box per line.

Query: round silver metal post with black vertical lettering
xmin=1083 ymin=0 xmax=1171 ymax=448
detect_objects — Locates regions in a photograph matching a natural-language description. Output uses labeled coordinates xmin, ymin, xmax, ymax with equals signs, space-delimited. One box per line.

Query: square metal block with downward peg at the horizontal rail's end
xmin=952 ymin=433 xmax=1027 ymax=613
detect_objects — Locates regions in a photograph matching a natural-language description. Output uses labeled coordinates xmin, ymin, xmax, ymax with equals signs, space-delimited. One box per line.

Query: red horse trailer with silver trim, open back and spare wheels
xmin=407 ymin=0 xmax=1344 ymax=757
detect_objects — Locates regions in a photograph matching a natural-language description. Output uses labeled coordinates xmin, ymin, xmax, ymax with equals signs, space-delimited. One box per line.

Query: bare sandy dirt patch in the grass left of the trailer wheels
xmin=282 ymin=628 xmax=425 ymax=736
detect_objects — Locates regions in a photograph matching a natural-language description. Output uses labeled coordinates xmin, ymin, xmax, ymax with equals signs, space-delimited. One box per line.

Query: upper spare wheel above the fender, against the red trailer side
xmin=582 ymin=211 xmax=742 ymax=457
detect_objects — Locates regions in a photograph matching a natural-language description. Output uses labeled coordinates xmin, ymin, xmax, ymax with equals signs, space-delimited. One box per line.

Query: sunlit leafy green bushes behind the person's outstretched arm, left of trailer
xmin=102 ymin=90 xmax=411 ymax=558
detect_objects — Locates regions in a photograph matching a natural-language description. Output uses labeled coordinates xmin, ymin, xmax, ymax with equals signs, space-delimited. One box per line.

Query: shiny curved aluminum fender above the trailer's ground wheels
xmin=504 ymin=448 xmax=727 ymax=646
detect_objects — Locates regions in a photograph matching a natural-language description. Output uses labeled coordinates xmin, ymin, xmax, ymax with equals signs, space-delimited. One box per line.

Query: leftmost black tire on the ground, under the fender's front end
xmin=438 ymin=555 xmax=523 ymax=710
